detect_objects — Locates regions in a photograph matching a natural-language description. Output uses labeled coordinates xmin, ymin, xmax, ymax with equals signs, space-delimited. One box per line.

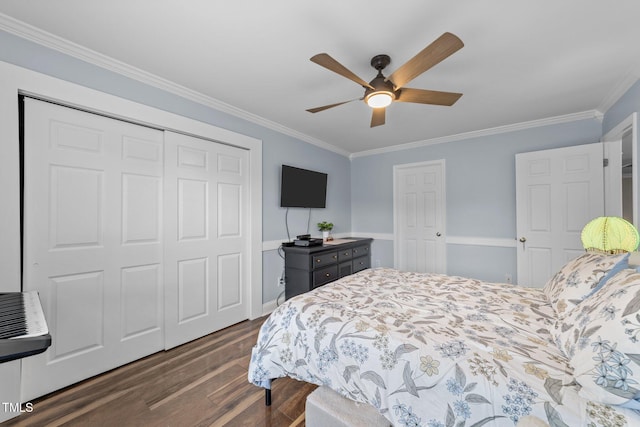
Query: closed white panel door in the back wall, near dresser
xmin=394 ymin=160 xmax=447 ymax=273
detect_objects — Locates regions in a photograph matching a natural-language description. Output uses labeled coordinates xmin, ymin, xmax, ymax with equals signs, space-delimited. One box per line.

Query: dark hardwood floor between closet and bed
xmin=2 ymin=318 xmax=316 ymax=427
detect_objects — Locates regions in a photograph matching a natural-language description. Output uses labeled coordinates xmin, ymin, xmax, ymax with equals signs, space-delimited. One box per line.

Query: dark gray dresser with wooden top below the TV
xmin=283 ymin=237 xmax=373 ymax=299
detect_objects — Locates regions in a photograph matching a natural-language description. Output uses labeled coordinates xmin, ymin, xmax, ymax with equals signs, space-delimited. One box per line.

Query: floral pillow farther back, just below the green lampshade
xmin=543 ymin=252 xmax=629 ymax=319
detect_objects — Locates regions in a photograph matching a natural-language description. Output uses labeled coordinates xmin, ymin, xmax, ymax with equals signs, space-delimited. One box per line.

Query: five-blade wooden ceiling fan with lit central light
xmin=307 ymin=33 xmax=464 ymax=127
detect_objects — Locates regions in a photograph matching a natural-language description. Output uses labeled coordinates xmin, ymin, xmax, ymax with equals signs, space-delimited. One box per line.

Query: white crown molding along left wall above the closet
xmin=0 ymin=13 xmax=350 ymax=157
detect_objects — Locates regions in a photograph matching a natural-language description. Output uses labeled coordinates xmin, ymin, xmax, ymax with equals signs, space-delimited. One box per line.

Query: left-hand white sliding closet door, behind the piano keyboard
xmin=22 ymin=99 xmax=163 ymax=402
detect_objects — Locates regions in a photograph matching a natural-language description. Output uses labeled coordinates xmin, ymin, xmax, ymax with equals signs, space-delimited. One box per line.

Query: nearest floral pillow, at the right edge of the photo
xmin=558 ymin=269 xmax=640 ymax=407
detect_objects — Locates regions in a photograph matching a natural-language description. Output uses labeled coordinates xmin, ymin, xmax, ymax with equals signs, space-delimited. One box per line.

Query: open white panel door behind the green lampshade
xmin=516 ymin=143 xmax=604 ymax=287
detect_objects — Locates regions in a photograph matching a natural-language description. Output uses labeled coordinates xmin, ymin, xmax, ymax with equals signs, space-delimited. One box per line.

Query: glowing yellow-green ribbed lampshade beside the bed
xmin=581 ymin=216 xmax=640 ymax=253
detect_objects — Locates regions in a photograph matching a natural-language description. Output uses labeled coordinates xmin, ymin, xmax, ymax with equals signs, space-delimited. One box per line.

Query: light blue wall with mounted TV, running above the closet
xmin=0 ymin=31 xmax=351 ymax=302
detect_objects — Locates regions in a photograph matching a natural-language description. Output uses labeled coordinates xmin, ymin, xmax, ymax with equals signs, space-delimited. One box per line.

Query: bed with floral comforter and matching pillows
xmin=248 ymin=253 xmax=640 ymax=427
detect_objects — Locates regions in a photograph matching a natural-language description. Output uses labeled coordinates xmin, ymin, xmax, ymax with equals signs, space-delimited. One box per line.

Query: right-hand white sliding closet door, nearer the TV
xmin=165 ymin=132 xmax=249 ymax=348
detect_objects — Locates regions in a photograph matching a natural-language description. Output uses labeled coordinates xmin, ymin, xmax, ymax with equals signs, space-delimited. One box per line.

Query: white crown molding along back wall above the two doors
xmin=349 ymin=110 xmax=604 ymax=159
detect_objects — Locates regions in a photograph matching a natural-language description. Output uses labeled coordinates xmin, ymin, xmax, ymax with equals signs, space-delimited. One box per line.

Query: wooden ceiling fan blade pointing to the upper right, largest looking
xmin=387 ymin=33 xmax=464 ymax=89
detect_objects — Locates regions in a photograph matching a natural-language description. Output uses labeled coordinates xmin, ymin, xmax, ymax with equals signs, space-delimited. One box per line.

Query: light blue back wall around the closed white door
xmin=351 ymin=119 xmax=601 ymax=282
